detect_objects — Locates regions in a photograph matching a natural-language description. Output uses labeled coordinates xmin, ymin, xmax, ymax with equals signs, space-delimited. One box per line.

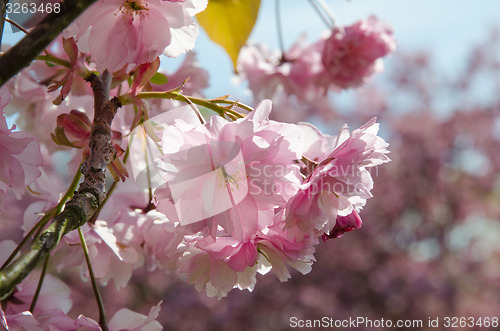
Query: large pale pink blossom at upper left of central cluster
xmin=155 ymin=101 xmax=300 ymax=242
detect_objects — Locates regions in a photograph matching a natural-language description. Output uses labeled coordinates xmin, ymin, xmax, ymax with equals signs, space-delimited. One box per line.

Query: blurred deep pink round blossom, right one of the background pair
xmin=322 ymin=16 xmax=396 ymax=88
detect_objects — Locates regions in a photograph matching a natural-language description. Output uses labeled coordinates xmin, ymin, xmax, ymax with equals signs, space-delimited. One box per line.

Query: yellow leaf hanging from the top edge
xmin=196 ymin=0 xmax=260 ymax=71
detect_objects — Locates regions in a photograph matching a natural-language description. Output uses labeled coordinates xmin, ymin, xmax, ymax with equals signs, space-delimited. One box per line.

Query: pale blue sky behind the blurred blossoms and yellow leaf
xmin=196 ymin=0 xmax=500 ymax=99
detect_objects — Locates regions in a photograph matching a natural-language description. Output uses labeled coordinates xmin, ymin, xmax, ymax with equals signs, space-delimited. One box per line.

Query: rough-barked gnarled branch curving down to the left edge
xmin=0 ymin=72 xmax=121 ymax=300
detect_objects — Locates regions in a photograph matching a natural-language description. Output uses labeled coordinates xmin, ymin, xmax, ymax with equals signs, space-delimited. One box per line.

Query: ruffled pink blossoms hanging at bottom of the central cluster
xmin=174 ymin=213 xmax=317 ymax=299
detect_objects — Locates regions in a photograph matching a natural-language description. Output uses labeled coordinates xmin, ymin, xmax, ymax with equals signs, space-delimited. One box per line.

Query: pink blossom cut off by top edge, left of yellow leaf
xmin=66 ymin=0 xmax=207 ymax=72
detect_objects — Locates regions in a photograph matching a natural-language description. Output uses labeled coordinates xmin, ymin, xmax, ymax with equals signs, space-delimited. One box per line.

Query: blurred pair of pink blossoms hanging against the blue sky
xmin=238 ymin=16 xmax=396 ymax=101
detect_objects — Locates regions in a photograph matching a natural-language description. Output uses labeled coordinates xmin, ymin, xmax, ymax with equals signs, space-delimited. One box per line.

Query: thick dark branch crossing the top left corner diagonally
xmin=0 ymin=0 xmax=96 ymax=87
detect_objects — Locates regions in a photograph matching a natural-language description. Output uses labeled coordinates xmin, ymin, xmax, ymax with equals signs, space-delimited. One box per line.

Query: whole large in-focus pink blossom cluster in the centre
xmin=141 ymin=100 xmax=389 ymax=298
